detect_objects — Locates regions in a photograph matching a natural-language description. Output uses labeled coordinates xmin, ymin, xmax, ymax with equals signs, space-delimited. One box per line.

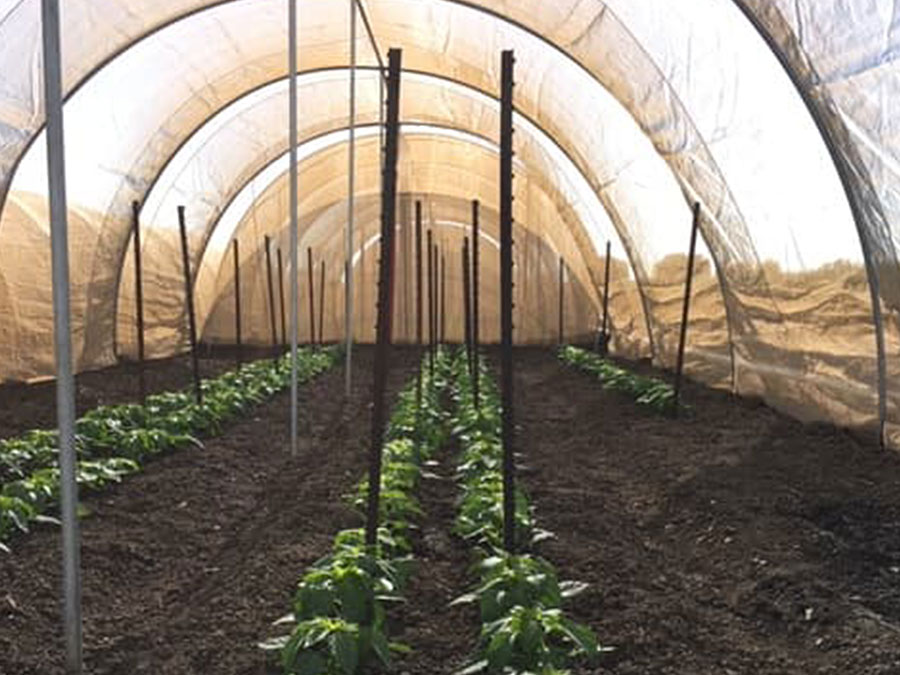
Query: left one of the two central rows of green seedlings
xmin=260 ymin=356 xmax=447 ymax=675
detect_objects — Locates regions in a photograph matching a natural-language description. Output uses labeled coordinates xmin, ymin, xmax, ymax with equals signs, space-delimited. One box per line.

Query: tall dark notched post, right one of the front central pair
xmin=500 ymin=50 xmax=517 ymax=553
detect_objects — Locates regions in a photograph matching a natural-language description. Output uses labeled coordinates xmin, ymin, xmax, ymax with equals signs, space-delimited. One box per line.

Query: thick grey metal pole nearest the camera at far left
xmin=41 ymin=0 xmax=82 ymax=675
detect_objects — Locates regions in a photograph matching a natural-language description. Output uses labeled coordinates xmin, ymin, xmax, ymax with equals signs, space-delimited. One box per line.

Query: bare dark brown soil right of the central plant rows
xmin=516 ymin=350 xmax=900 ymax=675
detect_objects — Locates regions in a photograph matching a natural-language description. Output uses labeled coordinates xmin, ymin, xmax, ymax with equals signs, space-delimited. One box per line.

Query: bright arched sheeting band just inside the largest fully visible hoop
xmin=117 ymin=71 xmax=643 ymax=362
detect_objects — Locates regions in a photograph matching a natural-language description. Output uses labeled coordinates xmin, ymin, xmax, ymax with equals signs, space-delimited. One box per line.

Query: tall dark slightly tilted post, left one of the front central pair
xmin=366 ymin=49 xmax=401 ymax=547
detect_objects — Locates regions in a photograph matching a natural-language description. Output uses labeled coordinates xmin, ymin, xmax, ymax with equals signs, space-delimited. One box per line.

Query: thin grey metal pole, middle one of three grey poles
xmin=288 ymin=0 xmax=300 ymax=457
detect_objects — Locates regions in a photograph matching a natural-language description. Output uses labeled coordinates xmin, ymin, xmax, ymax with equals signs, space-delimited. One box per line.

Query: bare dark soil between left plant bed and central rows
xmin=0 ymin=349 xmax=414 ymax=675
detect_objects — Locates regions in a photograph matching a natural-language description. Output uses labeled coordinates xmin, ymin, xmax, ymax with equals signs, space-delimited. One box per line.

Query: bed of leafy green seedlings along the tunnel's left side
xmin=0 ymin=349 xmax=339 ymax=549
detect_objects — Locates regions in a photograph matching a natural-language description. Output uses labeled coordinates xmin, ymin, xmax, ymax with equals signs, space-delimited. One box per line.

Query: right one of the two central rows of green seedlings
xmin=451 ymin=358 xmax=603 ymax=675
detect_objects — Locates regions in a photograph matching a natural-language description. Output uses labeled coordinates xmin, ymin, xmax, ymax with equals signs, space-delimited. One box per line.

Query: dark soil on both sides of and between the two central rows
xmin=0 ymin=350 xmax=900 ymax=675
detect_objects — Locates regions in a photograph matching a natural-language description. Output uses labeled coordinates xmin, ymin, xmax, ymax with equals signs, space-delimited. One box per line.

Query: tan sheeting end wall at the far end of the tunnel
xmin=203 ymin=193 xmax=596 ymax=344
